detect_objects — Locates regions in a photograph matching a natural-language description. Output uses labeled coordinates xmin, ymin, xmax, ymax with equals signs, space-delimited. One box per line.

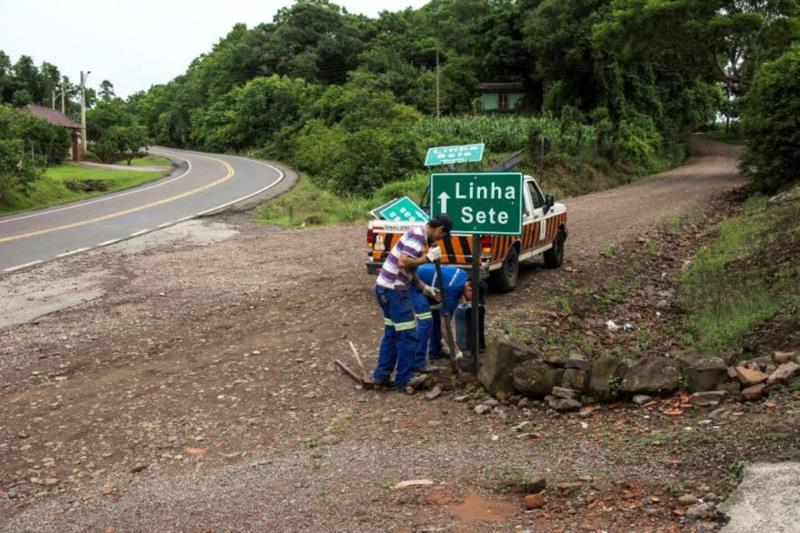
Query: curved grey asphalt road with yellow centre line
xmin=0 ymin=147 xmax=284 ymax=273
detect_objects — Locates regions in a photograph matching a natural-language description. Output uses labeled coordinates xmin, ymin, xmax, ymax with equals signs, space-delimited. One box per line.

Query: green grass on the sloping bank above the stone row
xmin=678 ymin=193 xmax=800 ymax=354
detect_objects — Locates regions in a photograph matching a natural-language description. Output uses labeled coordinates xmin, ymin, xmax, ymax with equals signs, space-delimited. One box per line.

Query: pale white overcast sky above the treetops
xmin=0 ymin=0 xmax=426 ymax=97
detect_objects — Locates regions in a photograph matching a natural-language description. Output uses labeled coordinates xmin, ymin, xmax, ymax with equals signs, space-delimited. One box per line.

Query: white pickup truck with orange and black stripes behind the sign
xmin=367 ymin=176 xmax=568 ymax=292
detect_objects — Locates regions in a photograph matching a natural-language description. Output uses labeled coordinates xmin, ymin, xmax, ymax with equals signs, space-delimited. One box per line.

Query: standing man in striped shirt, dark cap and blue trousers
xmin=372 ymin=214 xmax=453 ymax=392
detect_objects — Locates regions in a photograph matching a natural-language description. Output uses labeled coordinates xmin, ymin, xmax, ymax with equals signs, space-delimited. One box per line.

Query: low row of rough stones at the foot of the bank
xmin=478 ymin=338 xmax=800 ymax=411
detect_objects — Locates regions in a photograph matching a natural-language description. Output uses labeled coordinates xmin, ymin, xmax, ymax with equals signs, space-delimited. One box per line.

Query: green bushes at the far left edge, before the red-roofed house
xmin=0 ymin=105 xmax=69 ymax=203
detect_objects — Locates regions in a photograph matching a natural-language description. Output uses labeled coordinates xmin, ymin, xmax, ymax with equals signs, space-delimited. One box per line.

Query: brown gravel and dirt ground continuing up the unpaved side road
xmin=0 ymin=141 xmax=743 ymax=531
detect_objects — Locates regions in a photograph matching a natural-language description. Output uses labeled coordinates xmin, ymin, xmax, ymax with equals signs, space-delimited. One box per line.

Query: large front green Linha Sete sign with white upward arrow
xmin=431 ymin=172 xmax=525 ymax=235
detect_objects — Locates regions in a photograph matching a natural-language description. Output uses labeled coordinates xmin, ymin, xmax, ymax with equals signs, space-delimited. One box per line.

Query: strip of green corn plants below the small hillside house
xmin=413 ymin=116 xmax=595 ymax=153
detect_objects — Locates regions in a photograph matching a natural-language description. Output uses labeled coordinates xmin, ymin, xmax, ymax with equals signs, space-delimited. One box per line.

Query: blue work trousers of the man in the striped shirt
xmin=372 ymin=285 xmax=417 ymax=390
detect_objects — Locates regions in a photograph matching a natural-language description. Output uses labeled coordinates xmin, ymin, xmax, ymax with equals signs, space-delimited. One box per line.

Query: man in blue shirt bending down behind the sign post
xmin=410 ymin=264 xmax=472 ymax=372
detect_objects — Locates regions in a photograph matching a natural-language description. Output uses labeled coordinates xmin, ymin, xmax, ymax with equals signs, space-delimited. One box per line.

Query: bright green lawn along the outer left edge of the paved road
xmin=0 ymin=163 xmax=167 ymax=213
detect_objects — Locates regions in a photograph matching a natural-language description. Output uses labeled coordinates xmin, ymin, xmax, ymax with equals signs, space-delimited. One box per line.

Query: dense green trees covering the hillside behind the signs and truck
xmin=122 ymin=0 xmax=800 ymax=194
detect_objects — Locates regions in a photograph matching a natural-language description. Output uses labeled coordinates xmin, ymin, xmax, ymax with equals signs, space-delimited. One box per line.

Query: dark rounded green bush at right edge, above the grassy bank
xmin=742 ymin=45 xmax=800 ymax=192
